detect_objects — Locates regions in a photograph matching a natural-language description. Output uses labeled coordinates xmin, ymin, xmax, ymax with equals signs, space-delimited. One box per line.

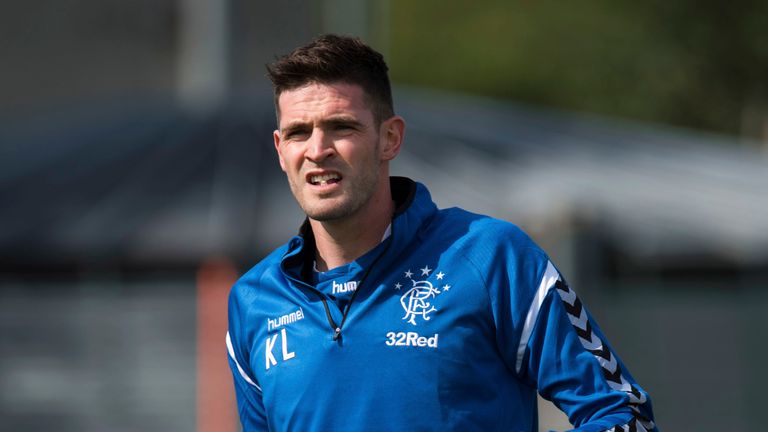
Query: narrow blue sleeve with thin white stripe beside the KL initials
xmin=226 ymin=289 xmax=269 ymax=432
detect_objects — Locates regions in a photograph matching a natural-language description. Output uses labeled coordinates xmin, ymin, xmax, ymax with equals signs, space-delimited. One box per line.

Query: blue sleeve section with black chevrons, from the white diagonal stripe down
xmin=515 ymin=260 xmax=658 ymax=432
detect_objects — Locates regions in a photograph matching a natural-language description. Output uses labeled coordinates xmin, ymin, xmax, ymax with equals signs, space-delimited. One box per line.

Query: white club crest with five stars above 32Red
xmin=395 ymin=266 xmax=451 ymax=325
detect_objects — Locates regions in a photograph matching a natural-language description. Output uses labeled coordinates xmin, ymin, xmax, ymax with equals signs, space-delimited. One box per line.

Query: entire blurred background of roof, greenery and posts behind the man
xmin=0 ymin=0 xmax=768 ymax=432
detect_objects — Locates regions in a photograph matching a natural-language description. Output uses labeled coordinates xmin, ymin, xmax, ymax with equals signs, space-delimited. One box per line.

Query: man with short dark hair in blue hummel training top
xmin=227 ymin=35 xmax=655 ymax=431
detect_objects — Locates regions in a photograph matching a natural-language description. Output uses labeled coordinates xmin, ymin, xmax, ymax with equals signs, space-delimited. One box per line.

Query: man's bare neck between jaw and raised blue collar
xmin=309 ymin=188 xmax=395 ymax=271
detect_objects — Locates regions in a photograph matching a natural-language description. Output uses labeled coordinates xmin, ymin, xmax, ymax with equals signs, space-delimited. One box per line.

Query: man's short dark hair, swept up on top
xmin=267 ymin=34 xmax=395 ymax=125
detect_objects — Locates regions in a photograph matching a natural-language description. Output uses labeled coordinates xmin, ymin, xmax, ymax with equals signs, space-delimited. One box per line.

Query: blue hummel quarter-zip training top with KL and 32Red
xmin=229 ymin=179 xmax=654 ymax=432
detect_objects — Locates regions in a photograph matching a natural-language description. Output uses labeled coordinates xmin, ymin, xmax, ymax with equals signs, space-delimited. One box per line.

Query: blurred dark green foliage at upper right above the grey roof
xmin=388 ymin=0 xmax=768 ymax=135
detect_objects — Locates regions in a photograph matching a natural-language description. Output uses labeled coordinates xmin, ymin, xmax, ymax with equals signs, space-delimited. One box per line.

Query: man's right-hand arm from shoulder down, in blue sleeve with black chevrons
xmin=466 ymin=219 xmax=657 ymax=432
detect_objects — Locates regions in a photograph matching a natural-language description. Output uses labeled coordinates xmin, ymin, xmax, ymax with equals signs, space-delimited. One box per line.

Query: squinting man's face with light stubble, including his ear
xmin=274 ymin=83 xmax=402 ymax=221
